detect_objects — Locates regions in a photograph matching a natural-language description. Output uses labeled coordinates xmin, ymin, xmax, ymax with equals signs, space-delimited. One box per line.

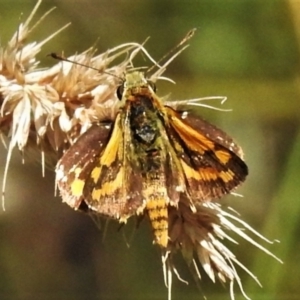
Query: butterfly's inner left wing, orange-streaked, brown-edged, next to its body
xmin=83 ymin=113 xmax=142 ymax=221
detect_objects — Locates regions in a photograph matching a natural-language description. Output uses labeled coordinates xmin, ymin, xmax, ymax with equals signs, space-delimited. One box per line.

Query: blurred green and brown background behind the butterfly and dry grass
xmin=0 ymin=0 xmax=300 ymax=300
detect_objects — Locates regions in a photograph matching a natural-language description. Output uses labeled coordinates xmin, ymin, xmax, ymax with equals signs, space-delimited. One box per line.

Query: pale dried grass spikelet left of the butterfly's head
xmin=0 ymin=1 xmax=141 ymax=203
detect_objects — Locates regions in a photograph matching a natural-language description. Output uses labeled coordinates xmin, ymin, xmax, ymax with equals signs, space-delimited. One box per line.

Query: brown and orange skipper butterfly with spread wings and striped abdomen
xmin=56 ymin=70 xmax=248 ymax=248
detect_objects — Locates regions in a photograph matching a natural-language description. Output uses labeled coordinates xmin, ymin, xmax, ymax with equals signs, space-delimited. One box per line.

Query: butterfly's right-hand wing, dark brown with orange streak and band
xmin=166 ymin=107 xmax=248 ymax=201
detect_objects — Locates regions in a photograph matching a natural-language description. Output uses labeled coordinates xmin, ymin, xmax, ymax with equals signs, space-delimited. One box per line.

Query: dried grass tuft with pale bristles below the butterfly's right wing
xmin=162 ymin=202 xmax=282 ymax=300
